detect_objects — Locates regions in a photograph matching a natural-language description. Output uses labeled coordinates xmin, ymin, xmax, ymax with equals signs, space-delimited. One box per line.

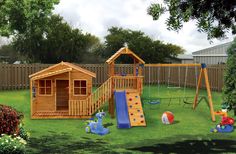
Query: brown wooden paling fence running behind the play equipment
xmin=0 ymin=64 xmax=225 ymax=91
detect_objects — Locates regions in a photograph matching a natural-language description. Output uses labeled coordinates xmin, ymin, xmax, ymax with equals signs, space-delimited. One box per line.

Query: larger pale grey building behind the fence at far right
xmin=192 ymin=42 xmax=232 ymax=65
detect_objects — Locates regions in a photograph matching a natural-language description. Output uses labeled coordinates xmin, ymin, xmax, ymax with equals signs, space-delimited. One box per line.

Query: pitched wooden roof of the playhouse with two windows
xmin=29 ymin=61 xmax=96 ymax=80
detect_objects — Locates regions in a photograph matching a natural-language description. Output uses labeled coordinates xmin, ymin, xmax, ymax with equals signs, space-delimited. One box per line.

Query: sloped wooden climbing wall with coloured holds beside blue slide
xmin=126 ymin=92 xmax=146 ymax=126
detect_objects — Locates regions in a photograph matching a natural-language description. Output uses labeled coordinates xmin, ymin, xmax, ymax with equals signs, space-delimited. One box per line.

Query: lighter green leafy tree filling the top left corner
xmin=0 ymin=0 xmax=63 ymax=61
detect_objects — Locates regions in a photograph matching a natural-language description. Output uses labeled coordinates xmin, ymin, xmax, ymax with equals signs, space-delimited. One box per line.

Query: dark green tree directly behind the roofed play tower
xmin=99 ymin=27 xmax=184 ymax=63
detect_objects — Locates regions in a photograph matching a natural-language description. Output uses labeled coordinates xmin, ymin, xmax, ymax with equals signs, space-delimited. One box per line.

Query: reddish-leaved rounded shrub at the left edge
xmin=0 ymin=105 xmax=22 ymax=135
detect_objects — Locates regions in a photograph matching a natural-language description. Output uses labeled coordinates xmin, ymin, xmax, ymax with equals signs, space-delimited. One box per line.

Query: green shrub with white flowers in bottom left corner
xmin=0 ymin=134 xmax=26 ymax=154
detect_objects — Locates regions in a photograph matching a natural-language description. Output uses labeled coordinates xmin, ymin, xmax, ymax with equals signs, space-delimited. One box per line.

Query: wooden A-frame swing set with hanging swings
xmin=145 ymin=64 xmax=215 ymax=121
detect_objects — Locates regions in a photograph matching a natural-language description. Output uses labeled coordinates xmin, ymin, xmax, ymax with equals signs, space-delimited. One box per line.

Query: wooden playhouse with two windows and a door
xmin=29 ymin=62 xmax=96 ymax=118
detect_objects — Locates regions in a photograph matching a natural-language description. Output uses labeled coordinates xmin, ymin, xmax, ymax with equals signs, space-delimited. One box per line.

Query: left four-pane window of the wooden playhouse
xmin=39 ymin=80 xmax=52 ymax=95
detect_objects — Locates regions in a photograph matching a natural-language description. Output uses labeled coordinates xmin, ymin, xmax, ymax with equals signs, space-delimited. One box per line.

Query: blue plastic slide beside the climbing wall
xmin=115 ymin=91 xmax=131 ymax=128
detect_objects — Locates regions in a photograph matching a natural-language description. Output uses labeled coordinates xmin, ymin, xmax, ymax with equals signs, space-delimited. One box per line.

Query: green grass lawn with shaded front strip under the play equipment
xmin=0 ymin=86 xmax=236 ymax=153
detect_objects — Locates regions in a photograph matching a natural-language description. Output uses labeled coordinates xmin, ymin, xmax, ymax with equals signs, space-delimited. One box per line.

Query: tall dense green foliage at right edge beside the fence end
xmin=223 ymin=38 xmax=236 ymax=115
